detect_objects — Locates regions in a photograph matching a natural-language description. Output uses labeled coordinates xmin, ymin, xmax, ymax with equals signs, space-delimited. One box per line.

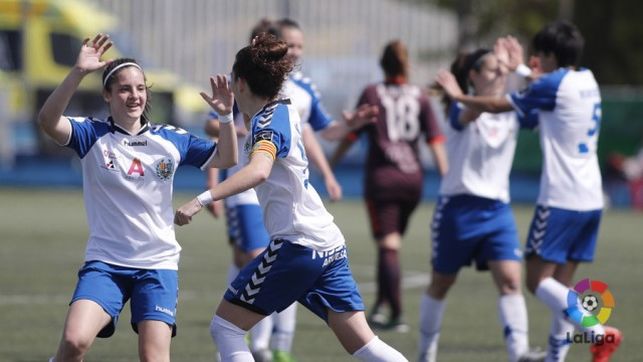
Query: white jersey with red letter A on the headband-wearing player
xmin=67 ymin=117 xmax=216 ymax=270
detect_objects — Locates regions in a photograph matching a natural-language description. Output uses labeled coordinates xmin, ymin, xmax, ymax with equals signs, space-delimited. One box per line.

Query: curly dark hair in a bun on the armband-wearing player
xmin=232 ymin=33 xmax=293 ymax=99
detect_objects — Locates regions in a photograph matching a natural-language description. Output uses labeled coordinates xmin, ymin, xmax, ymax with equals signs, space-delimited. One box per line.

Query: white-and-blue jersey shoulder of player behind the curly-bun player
xmin=281 ymin=72 xmax=333 ymax=131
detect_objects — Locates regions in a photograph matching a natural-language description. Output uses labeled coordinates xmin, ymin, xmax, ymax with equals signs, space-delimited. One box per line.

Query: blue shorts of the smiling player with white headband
xmin=70 ymin=261 xmax=179 ymax=338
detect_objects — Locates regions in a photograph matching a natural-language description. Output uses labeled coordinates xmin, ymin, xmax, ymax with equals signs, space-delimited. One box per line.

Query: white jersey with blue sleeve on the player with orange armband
xmin=242 ymin=99 xmax=344 ymax=251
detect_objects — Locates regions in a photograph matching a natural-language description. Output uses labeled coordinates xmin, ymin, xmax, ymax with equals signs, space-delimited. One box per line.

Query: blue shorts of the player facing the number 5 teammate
xmin=431 ymin=195 xmax=522 ymax=274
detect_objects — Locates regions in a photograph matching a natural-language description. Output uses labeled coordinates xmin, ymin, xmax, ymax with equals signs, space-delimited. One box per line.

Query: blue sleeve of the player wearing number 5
xmin=509 ymin=69 xmax=567 ymax=118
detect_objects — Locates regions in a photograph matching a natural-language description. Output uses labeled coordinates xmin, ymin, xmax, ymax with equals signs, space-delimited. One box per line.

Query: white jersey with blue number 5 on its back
xmin=508 ymin=68 xmax=603 ymax=211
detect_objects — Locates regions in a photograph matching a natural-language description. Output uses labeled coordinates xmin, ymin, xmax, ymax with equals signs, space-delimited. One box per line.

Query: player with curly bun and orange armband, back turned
xmin=175 ymin=34 xmax=406 ymax=361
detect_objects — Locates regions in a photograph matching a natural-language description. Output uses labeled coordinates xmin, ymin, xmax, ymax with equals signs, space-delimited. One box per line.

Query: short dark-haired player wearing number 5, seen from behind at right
xmin=437 ymin=21 xmax=622 ymax=362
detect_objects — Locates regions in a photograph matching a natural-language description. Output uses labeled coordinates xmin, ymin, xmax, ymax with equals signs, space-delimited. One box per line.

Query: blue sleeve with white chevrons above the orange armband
xmin=252 ymin=104 xmax=292 ymax=158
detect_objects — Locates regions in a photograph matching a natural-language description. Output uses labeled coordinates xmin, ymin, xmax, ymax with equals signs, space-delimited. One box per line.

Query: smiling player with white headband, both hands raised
xmin=38 ymin=34 xmax=237 ymax=362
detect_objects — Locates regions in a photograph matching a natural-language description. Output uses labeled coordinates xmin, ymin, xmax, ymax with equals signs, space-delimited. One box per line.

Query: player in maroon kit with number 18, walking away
xmin=333 ymin=41 xmax=447 ymax=332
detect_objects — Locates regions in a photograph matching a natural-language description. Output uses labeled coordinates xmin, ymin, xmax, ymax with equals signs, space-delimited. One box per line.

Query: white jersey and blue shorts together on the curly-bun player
xmin=224 ymin=99 xmax=364 ymax=320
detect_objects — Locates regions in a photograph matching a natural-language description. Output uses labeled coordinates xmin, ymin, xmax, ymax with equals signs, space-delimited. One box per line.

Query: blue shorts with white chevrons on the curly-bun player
xmin=224 ymin=239 xmax=364 ymax=321
